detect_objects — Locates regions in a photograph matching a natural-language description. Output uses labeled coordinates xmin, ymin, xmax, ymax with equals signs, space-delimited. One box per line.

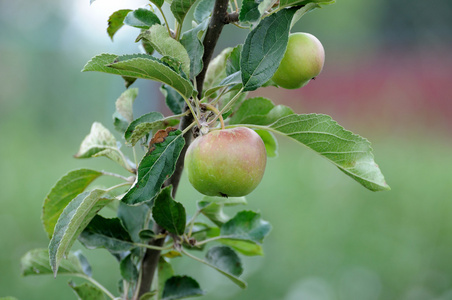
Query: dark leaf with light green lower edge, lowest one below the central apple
xmin=206 ymin=246 xmax=246 ymax=289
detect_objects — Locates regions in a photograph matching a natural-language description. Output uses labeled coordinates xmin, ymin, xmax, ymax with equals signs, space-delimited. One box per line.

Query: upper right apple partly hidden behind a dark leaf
xmin=272 ymin=32 xmax=325 ymax=89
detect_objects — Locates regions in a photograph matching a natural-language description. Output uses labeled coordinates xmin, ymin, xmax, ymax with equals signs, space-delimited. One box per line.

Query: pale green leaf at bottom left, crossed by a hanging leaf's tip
xmin=20 ymin=249 xmax=90 ymax=276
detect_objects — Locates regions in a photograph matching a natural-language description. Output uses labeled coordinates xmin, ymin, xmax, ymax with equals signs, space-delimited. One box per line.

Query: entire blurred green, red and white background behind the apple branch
xmin=0 ymin=0 xmax=452 ymax=300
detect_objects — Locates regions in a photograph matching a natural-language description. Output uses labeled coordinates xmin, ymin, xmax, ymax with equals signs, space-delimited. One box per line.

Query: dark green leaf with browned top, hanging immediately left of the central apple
xmin=122 ymin=130 xmax=185 ymax=205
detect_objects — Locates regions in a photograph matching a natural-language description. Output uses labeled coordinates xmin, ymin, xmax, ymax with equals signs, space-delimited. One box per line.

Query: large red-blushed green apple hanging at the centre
xmin=185 ymin=127 xmax=267 ymax=197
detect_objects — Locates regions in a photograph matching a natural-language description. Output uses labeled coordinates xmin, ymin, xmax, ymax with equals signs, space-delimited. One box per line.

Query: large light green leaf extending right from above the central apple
xmin=268 ymin=114 xmax=390 ymax=191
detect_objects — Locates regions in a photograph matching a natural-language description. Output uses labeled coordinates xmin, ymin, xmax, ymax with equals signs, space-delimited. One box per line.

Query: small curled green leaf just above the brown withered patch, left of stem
xmin=124 ymin=112 xmax=179 ymax=146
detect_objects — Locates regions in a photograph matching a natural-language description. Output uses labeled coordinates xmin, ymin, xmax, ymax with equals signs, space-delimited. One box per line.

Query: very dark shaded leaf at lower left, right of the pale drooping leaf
xmin=78 ymin=215 xmax=134 ymax=253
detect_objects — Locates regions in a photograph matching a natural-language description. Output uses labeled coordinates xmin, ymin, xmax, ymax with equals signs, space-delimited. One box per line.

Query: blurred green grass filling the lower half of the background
xmin=0 ymin=121 xmax=452 ymax=300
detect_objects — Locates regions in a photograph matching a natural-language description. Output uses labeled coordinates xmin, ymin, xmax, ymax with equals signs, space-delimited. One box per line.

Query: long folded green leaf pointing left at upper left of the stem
xmin=82 ymin=54 xmax=193 ymax=98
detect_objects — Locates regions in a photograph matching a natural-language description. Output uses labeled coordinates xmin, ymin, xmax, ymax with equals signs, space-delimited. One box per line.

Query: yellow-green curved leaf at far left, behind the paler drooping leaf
xmin=41 ymin=169 xmax=103 ymax=239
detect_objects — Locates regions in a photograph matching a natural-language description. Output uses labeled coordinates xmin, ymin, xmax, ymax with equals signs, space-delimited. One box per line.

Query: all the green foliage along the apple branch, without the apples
xmin=21 ymin=0 xmax=389 ymax=300
